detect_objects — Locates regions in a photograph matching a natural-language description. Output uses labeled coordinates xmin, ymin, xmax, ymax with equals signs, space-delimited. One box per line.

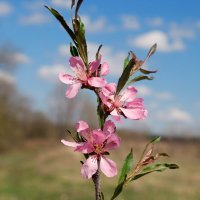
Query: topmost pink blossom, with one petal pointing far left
xmin=59 ymin=56 xmax=109 ymax=98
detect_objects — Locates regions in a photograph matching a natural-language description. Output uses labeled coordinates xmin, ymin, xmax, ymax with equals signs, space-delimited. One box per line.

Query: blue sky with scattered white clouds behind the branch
xmin=0 ymin=0 xmax=200 ymax=134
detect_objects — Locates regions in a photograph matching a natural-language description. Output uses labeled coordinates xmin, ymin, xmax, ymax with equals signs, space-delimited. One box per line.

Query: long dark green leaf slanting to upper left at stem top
xmin=45 ymin=5 xmax=76 ymax=43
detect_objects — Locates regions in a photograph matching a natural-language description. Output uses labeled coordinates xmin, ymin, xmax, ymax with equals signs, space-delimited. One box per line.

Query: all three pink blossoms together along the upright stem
xmin=59 ymin=56 xmax=147 ymax=179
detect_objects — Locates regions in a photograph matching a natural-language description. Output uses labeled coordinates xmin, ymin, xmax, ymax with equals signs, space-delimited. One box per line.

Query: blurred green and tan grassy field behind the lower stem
xmin=0 ymin=139 xmax=200 ymax=200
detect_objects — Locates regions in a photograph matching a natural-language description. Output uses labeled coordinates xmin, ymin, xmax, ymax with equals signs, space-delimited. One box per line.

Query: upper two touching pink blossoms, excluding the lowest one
xmin=59 ymin=56 xmax=147 ymax=121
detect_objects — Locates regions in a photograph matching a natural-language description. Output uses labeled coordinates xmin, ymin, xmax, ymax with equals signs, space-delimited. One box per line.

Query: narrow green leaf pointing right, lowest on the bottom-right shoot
xmin=131 ymin=163 xmax=179 ymax=181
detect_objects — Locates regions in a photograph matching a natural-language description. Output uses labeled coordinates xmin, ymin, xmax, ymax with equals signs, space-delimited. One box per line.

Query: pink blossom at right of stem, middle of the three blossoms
xmin=100 ymin=83 xmax=147 ymax=121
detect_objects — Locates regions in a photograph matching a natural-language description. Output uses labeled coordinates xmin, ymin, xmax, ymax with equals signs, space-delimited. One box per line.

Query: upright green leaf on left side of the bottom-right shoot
xmin=118 ymin=149 xmax=133 ymax=184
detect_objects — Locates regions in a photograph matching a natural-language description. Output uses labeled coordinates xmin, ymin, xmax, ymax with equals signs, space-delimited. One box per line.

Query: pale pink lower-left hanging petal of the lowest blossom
xmin=81 ymin=156 xmax=98 ymax=179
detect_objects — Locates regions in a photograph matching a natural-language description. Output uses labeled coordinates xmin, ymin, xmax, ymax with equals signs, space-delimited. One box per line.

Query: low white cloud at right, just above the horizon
xmin=157 ymin=107 xmax=193 ymax=123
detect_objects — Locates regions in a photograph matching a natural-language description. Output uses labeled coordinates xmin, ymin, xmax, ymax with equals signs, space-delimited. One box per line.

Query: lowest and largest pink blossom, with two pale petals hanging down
xmin=61 ymin=120 xmax=120 ymax=179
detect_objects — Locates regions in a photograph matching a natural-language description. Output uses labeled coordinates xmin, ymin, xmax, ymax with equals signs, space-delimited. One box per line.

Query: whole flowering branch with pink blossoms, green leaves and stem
xmin=45 ymin=0 xmax=178 ymax=200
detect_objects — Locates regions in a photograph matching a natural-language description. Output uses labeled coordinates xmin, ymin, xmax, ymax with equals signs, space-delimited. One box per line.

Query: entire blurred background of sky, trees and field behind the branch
xmin=0 ymin=0 xmax=200 ymax=200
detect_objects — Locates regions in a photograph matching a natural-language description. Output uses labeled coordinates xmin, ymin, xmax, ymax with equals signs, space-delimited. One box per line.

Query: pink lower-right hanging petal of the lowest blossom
xmin=100 ymin=156 xmax=117 ymax=177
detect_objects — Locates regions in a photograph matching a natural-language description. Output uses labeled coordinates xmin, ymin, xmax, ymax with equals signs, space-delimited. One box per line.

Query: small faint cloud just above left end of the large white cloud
xmin=121 ymin=15 xmax=140 ymax=30
